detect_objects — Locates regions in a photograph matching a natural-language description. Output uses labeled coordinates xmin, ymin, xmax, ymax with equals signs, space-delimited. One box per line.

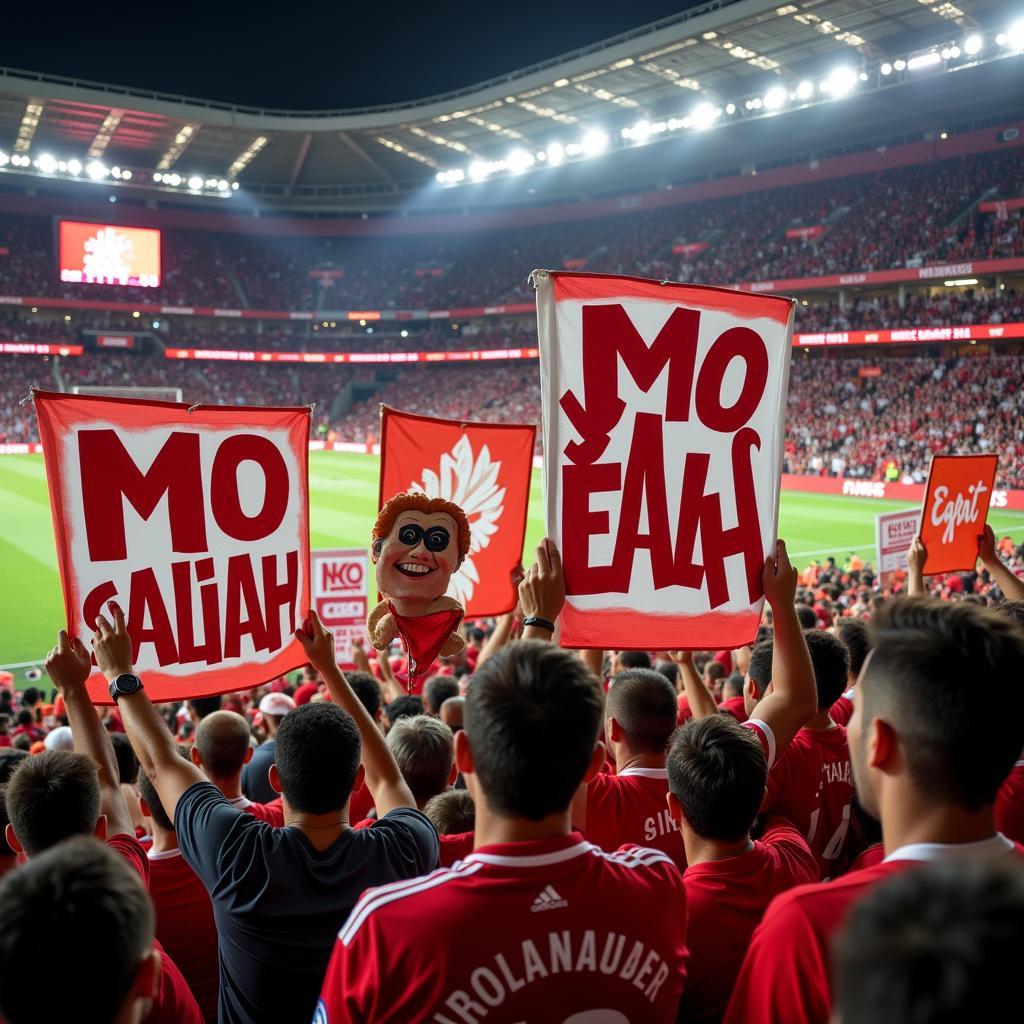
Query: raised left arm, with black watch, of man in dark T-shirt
xmin=92 ymin=602 xmax=206 ymax=821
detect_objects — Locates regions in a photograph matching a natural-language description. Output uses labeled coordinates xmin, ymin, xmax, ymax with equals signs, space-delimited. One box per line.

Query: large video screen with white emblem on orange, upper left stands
xmin=59 ymin=220 xmax=160 ymax=288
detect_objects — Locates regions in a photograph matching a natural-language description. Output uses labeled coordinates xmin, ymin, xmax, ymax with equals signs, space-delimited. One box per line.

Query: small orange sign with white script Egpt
xmin=921 ymin=455 xmax=998 ymax=575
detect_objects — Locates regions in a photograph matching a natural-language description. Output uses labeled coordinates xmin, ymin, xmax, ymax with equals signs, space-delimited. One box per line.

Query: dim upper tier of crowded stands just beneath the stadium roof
xmin=0 ymin=146 xmax=1024 ymax=311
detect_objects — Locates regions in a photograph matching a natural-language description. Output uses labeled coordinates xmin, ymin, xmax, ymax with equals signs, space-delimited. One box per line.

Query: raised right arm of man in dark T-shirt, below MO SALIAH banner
xmin=295 ymin=608 xmax=416 ymax=817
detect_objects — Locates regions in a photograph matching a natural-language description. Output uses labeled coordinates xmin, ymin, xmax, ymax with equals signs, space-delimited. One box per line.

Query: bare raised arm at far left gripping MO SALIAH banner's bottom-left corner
xmin=45 ymin=630 xmax=135 ymax=836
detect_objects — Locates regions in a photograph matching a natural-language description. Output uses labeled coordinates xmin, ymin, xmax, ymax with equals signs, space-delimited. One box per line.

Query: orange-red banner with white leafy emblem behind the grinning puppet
xmin=378 ymin=406 xmax=537 ymax=618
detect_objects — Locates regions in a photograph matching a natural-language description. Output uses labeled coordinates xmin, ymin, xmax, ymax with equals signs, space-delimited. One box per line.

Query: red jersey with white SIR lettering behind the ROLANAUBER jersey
xmin=585 ymin=768 xmax=686 ymax=870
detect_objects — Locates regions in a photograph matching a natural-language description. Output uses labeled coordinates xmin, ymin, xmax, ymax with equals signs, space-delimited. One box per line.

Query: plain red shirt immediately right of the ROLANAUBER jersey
xmin=679 ymin=818 xmax=818 ymax=1022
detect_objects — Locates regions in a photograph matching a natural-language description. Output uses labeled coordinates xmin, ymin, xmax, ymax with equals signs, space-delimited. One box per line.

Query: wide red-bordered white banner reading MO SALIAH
xmin=35 ymin=391 xmax=309 ymax=703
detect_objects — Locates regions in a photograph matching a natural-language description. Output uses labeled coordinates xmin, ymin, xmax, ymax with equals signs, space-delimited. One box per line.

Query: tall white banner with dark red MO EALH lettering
xmin=534 ymin=271 xmax=795 ymax=650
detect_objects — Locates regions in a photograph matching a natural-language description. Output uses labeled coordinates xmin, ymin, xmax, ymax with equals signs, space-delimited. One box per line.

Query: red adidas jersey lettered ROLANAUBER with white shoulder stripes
xmin=313 ymin=833 xmax=686 ymax=1024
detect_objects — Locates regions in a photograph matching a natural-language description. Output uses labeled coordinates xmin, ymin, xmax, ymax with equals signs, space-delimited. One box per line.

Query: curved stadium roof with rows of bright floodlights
xmin=0 ymin=0 xmax=1024 ymax=210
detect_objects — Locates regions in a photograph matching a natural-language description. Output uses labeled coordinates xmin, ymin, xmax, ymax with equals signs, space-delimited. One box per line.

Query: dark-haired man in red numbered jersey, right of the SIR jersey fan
xmin=755 ymin=630 xmax=853 ymax=879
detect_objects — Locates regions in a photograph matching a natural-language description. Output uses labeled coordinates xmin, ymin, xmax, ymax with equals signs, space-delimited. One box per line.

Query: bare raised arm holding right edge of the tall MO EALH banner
xmin=751 ymin=541 xmax=818 ymax=760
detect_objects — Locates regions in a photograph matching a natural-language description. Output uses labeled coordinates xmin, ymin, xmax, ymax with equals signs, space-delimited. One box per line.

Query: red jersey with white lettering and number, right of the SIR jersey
xmin=764 ymin=726 xmax=853 ymax=879
